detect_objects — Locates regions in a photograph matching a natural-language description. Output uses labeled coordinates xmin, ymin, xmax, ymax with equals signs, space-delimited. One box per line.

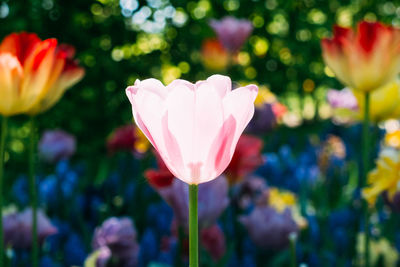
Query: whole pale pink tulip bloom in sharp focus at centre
xmin=126 ymin=75 xmax=258 ymax=185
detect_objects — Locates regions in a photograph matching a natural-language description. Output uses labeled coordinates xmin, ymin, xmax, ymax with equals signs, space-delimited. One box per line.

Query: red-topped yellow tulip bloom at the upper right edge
xmin=321 ymin=21 xmax=400 ymax=92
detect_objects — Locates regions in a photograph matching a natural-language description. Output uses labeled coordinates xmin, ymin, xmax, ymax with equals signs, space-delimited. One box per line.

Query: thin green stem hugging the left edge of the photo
xmin=0 ymin=117 xmax=8 ymax=266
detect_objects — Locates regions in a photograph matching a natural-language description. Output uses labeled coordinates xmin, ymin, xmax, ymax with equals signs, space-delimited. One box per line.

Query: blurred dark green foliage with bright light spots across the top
xmin=0 ymin=0 xmax=400 ymax=174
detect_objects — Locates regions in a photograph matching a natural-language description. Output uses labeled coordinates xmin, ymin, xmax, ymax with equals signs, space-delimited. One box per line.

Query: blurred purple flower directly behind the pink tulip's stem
xmin=158 ymin=176 xmax=229 ymax=228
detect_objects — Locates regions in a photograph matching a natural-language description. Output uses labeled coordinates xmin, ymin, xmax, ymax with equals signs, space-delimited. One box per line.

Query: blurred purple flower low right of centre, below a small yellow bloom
xmin=239 ymin=206 xmax=298 ymax=250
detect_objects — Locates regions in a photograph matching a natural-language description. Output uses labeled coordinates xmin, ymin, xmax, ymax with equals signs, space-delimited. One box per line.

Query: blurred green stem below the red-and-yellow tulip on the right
xmin=360 ymin=92 xmax=371 ymax=267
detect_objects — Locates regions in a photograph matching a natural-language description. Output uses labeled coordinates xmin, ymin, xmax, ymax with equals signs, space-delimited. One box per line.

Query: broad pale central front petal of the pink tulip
xmin=166 ymin=81 xmax=223 ymax=182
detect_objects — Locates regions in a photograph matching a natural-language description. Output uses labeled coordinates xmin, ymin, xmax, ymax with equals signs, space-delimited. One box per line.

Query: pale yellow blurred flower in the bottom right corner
xmin=357 ymin=233 xmax=399 ymax=266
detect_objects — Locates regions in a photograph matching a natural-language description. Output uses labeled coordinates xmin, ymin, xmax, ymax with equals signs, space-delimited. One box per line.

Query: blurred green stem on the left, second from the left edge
xmin=28 ymin=116 xmax=39 ymax=267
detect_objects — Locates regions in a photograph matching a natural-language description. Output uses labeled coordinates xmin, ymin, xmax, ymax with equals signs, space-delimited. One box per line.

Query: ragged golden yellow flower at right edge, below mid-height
xmin=362 ymin=147 xmax=400 ymax=205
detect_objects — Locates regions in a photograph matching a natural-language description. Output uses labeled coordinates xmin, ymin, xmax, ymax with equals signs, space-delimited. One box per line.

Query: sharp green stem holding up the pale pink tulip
xmin=189 ymin=184 xmax=199 ymax=267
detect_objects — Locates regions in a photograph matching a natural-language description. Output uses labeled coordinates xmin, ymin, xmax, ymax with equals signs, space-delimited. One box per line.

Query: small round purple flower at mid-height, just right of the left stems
xmin=38 ymin=130 xmax=76 ymax=163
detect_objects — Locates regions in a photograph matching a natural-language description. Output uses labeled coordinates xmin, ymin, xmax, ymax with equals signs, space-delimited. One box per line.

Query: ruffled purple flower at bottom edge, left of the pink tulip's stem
xmin=92 ymin=217 xmax=139 ymax=266
